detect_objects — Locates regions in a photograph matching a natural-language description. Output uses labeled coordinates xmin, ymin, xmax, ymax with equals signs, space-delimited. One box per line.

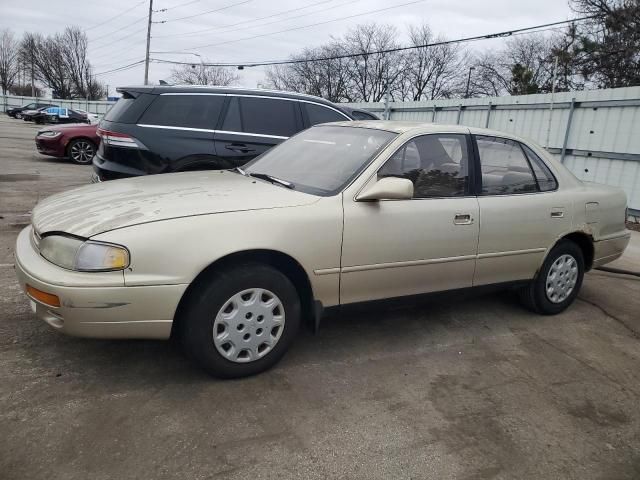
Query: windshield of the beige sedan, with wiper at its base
xmin=244 ymin=125 xmax=397 ymax=196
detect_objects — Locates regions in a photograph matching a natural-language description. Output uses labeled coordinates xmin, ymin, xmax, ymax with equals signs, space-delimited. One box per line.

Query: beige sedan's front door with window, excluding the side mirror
xmin=340 ymin=134 xmax=479 ymax=303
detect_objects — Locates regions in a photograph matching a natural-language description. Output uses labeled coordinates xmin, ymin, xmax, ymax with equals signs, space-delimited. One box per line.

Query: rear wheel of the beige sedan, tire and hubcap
xmin=519 ymin=240 xmax=584 ymax=315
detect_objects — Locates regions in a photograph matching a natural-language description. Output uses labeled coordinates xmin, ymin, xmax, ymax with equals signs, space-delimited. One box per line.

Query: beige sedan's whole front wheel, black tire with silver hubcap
xmin=178 ymin=263 xmax=301 ymax=378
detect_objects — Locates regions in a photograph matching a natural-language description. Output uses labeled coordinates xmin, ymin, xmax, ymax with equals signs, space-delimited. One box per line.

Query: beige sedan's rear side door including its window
xmin=473 ymin=135 xmax=572 ymax=285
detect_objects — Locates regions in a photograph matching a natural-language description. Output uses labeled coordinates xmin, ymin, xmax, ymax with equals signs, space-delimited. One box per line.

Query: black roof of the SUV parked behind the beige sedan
xmin=116 ymin=85 xmax=348 ymax=113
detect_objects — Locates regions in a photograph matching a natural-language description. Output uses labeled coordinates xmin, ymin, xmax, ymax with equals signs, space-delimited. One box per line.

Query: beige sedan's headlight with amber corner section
xmin=40 ymin=235 xmax=129 ymax=272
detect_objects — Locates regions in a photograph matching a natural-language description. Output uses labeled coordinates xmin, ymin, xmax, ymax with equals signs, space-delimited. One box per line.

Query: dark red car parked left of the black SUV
xmin=36 ymin=124 xmax=100 ymax=165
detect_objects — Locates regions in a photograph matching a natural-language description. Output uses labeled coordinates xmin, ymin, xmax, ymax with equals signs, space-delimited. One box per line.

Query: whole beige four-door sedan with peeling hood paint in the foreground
xmin=16 ymin=121 xmax=629 ymax=377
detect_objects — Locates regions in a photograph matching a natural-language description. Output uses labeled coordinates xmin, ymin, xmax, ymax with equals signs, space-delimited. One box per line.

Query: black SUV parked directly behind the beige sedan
xmin=93 ymin=86 xmax=354 ymax=181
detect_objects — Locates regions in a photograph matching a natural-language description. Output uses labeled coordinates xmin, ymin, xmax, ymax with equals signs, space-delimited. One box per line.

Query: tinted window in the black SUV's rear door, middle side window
xmin=239 ymin=97 xmax=298 ymax=137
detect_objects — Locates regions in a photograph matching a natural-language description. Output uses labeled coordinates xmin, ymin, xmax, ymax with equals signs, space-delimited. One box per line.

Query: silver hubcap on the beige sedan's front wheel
xmin=213 ymin=288 xmax=285 ymax=363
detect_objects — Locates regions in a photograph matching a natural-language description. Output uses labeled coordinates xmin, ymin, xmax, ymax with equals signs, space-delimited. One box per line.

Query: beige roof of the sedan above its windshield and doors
xmin=316 ymin=120 xmax=532 ymax=140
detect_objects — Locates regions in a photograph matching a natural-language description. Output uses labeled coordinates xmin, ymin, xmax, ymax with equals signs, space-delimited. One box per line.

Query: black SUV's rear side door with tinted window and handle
xmin=215 ymin=95 xmax=302 ymax=166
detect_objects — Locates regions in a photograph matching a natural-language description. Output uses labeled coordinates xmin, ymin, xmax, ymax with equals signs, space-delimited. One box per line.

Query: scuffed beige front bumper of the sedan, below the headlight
xmin=15 ymin=227 xmax=188 ymax=339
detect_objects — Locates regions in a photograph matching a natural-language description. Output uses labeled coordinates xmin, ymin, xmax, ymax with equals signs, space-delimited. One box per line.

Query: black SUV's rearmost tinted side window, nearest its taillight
xmin=139 ymin=95 xmax=224 ymax=130
